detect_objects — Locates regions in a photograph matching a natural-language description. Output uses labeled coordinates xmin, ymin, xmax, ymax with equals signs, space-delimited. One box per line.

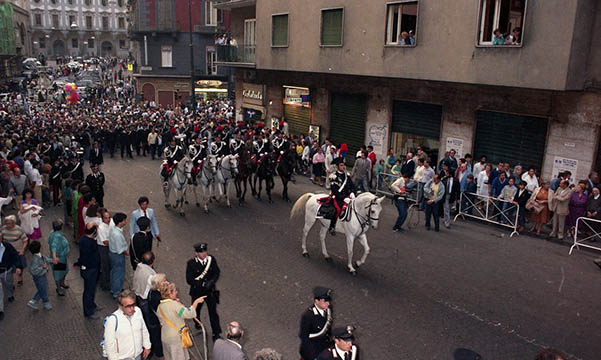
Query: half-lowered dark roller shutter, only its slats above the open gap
xmin=392 ymin=101 xmax=442 ymax=140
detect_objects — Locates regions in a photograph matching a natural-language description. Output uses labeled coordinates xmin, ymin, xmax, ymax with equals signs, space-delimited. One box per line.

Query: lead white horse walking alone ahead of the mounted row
xmin=290 ymin=192 xmax=384 ymax=275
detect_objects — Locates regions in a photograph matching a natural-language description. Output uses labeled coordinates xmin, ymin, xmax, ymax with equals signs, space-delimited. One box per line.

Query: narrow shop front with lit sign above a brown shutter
xmin=284 ymin=86 xmax=311 ymax=135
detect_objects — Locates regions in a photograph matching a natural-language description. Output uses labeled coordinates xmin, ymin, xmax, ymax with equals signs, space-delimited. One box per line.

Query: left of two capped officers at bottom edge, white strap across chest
xmin=299 ymin=286 xmax=334 ymax=360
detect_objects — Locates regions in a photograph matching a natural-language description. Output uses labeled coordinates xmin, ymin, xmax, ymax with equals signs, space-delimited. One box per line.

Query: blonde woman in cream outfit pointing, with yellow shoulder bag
xmin=157 ymin=281 xmax=206 ymax=360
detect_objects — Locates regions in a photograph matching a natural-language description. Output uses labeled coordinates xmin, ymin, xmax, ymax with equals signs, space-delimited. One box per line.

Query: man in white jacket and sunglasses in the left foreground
xmin=104 ymin=290 xmax=151 ymax=360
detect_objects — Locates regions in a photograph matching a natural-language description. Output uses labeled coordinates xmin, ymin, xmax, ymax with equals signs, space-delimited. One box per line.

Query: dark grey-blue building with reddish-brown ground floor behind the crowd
xmin=130 ymin=0 xmax=231 ymax=107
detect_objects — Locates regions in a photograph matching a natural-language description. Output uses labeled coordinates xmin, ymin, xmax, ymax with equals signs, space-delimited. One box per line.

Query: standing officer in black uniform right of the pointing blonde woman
xmin=186 ymin=243 xmax=221 ymax=342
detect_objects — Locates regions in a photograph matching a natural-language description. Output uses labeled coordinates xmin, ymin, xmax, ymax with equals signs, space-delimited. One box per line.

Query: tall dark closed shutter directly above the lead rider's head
xmin=330 ymin=93 xmax=367 ymax=165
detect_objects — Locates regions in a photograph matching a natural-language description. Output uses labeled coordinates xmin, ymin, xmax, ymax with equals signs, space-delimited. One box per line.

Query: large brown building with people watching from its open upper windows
xmin=218 ymin=0 xmax=601 ymax=179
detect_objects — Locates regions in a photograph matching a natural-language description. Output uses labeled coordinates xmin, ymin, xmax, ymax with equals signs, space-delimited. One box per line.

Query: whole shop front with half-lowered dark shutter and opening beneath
xmin=390 ymin=100 xmax=442 ymax=167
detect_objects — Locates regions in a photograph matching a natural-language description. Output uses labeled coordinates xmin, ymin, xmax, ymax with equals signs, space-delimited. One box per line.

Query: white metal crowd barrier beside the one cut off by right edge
xmin=453 ymin=192 xmax=520 ymax=237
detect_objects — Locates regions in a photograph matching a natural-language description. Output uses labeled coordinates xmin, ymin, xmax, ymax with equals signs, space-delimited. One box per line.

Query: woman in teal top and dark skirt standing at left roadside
xmin=48 ymin=219 xmax=71 ymax=296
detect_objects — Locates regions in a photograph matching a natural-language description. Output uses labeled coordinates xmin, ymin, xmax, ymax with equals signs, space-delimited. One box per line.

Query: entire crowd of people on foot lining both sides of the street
xmin=0 ymin=54 xmax=576 ymax=360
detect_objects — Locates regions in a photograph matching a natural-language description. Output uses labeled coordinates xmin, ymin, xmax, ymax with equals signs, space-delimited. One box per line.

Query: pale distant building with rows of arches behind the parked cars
xmin=27 ymin=0 xmax=129 ymax=59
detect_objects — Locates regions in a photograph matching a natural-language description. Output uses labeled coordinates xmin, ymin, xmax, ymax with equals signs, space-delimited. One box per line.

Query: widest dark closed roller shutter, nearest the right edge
xmin=474 ymin=110 xmax=548 ymax=171
